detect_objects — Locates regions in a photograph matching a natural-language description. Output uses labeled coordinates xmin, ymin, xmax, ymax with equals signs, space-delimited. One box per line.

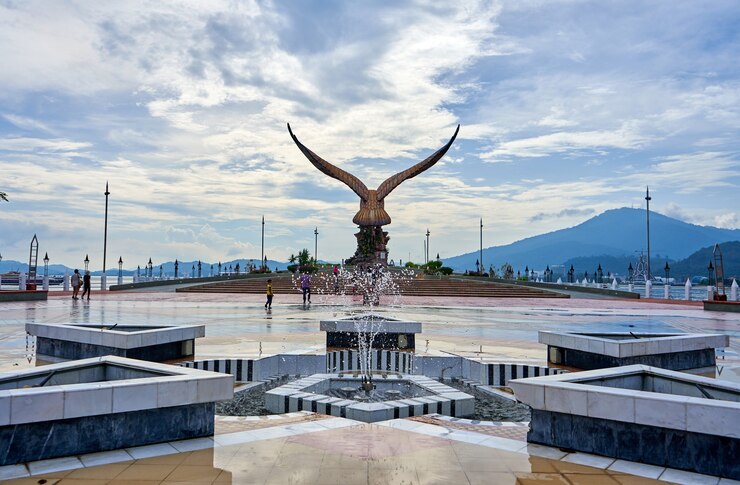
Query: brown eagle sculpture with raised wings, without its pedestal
xmin=288 ymin=123 xmax=460 ymax=227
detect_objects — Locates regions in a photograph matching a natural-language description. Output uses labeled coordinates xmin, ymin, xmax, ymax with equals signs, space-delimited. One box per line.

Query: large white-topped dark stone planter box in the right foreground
xmin=509 ymin=365 xmax=740 ymax=480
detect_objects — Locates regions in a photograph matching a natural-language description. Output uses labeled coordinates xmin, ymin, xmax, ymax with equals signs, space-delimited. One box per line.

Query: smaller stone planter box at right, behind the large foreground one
xmin=539 ymin=331 xmax=730 ymax=370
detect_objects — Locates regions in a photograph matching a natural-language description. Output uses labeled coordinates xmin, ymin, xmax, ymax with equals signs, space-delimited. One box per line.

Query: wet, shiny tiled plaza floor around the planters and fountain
xmin=0 ymin=292 xmax=740 ymax=485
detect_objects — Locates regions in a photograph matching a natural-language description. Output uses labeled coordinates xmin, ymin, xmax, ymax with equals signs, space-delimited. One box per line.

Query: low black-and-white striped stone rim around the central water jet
xmin=265 ymin=374 xmax=474 ymax=423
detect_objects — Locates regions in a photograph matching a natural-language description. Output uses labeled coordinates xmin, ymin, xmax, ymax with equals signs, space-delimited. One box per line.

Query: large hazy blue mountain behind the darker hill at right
xmin=444 ymin=208 xmax=740 ymax=273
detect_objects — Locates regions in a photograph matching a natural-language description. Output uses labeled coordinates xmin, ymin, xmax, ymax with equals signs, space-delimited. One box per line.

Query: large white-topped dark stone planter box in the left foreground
xmin=0 ymin=356 xmax=234 ymax=465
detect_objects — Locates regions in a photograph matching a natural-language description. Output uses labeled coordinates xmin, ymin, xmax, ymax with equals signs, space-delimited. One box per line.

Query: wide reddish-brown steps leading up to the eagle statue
xmin=177 ymin=276 xmax=569 ymax=298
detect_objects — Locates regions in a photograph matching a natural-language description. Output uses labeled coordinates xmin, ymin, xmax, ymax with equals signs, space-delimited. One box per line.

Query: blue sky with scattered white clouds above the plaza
xmin=0 ymin=0 xmax=740 ymax=269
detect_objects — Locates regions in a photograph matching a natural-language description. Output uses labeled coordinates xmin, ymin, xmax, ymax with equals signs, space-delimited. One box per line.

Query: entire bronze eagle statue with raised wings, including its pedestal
xmin=288 ymin=123 xmax=460 ymax=264
